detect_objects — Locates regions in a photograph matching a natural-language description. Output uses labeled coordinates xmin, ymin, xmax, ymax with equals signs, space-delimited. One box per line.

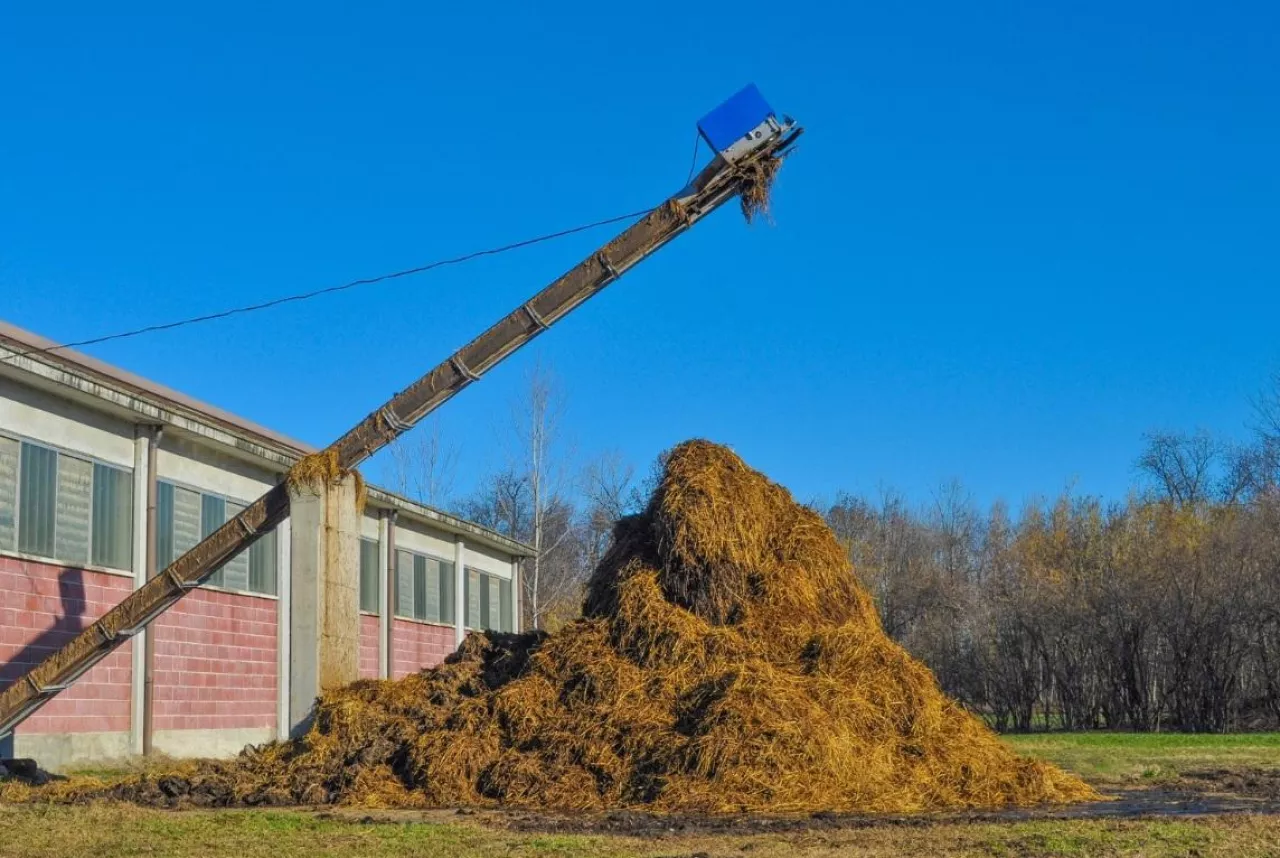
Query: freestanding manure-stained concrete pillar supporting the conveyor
xmin=289 ymin=476 xmax=360 ymax=735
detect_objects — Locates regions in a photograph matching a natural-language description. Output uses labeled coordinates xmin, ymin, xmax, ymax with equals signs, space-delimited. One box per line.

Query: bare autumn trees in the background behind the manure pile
xmin=389 ymin=371 xmax=1280 ymax=731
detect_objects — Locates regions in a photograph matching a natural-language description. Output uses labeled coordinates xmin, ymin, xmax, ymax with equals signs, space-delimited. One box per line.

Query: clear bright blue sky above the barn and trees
xmin=0 ymin=0 xmax=1280 ymax=514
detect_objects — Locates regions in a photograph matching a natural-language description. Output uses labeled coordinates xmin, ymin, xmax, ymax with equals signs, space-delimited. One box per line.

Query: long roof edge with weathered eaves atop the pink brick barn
xmin=0 ymin=320 xmax=534 ymax=557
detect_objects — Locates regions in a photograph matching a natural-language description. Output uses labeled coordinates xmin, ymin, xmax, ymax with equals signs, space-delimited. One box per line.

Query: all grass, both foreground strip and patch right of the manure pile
xmin=0 ymin=733 xmax=1280 ymax=858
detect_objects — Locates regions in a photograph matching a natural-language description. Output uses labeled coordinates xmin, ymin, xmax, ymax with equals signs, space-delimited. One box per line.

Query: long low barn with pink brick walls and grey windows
xmin=0 ymin=323 xmax=530 ymax=768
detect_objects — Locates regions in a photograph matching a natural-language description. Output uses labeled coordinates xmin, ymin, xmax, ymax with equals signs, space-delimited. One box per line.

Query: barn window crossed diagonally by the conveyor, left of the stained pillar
xmin=156 ymin=480 xmax=276 ymax=595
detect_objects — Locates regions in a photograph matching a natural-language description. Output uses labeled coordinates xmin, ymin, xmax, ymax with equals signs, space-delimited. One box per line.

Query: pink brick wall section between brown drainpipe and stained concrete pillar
xmin=151 ymin=588 xmax=278 ymax=730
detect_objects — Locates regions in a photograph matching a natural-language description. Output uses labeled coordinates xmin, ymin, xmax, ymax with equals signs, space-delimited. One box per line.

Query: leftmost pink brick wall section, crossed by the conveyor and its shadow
xmin=0 ymin=557 xmax=133 ymax=734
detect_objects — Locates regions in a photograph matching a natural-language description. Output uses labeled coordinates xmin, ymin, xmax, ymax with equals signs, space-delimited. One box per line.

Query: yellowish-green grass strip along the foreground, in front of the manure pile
xmin=0 ymin=804 xmax=1280 ymax=858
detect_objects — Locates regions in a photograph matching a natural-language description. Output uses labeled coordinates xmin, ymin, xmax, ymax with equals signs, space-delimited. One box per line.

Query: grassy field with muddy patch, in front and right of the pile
xmin=0 ymin=733 xmax=1280 ymax=858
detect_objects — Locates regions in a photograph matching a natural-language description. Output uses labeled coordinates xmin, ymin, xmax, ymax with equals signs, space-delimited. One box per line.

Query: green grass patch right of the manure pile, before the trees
xmin=1002 ymin=733 xmax=1280 ymax=785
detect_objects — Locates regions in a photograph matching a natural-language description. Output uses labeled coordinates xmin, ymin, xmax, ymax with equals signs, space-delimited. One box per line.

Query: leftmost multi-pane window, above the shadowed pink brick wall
xmin=0 ymin=438 xmax=133 ymax=570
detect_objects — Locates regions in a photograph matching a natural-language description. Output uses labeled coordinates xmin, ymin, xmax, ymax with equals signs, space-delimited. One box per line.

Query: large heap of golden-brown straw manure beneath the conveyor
xmin=49 ymin=441 xmax=1096 ymax=812
